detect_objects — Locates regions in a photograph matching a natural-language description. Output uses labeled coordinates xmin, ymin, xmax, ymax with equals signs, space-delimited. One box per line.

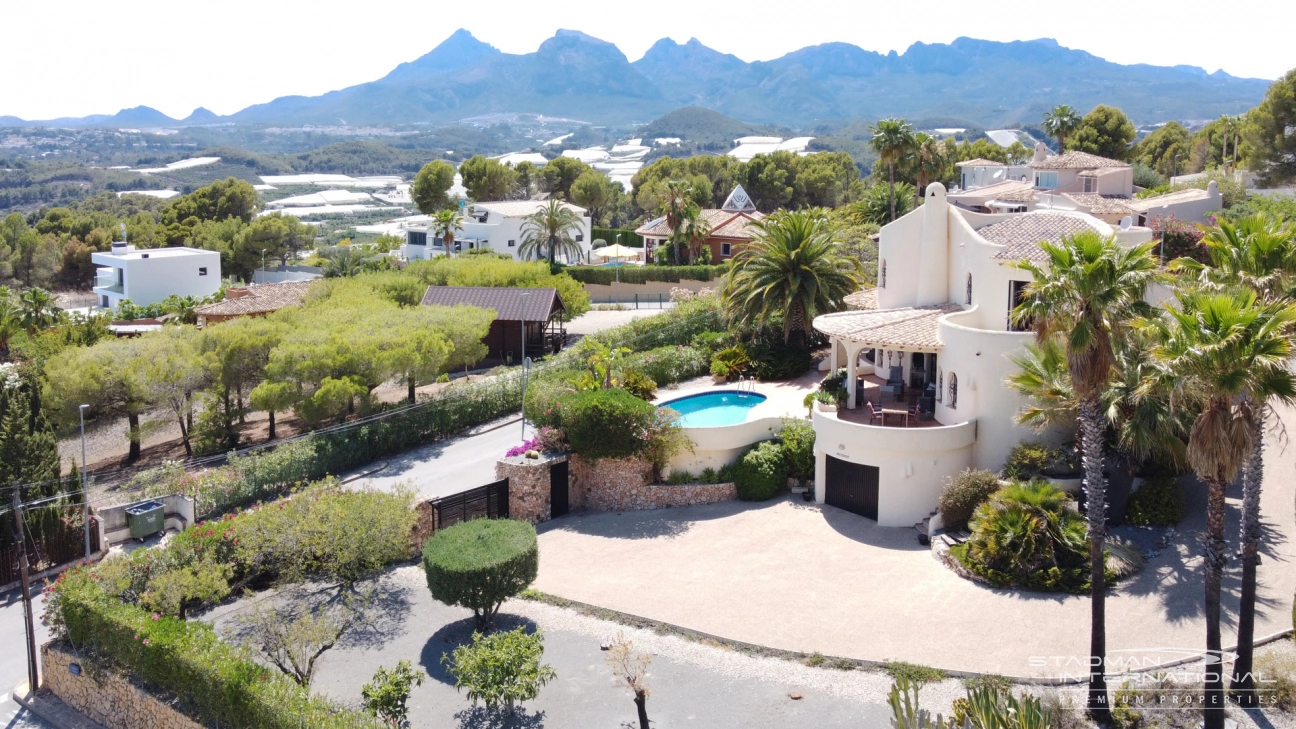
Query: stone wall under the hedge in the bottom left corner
xmin=40 ymin=643 xmax=203 ymax=729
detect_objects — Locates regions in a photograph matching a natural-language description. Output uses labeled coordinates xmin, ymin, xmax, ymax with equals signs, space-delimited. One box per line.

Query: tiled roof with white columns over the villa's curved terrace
xmin=814 ymin=304 xmax=963 ymax=409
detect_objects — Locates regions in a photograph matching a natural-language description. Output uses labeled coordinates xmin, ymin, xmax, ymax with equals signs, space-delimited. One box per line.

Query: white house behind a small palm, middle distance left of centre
xmin=402 ymin=200 xmax=591 ymax=261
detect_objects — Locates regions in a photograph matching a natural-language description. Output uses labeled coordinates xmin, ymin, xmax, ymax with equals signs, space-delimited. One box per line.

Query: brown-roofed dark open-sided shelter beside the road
xmin=422 ymin=287 xmax=566 ymax=363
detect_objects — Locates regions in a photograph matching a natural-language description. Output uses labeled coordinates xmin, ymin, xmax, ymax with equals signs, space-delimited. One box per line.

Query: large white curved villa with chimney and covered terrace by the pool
xmin=813 ymin=183 xmax=1152 ymax=527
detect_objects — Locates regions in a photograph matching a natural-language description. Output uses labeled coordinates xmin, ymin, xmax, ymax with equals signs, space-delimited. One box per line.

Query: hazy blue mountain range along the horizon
xmin=0 ymin=30 xmax=1269 ymax=127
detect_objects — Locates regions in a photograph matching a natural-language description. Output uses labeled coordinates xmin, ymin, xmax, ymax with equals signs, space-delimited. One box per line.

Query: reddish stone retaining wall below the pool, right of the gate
xmin=570 ymin=455 xmax=737 ymax=511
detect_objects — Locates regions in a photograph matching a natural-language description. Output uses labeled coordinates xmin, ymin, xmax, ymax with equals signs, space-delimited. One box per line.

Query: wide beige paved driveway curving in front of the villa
xmin=535 ymin=396 xmax=1296 ymax=676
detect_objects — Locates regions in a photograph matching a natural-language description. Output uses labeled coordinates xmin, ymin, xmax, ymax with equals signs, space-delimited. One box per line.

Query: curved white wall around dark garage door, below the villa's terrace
xmin=813 ymin=403 xmax=977 ymax=527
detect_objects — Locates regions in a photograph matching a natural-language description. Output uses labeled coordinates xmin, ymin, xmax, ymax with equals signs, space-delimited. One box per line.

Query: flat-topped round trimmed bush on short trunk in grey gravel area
xmin=422 ymin=519 xmax=540 ymax=632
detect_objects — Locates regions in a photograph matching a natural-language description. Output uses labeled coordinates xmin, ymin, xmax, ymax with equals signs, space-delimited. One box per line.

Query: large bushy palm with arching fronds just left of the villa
xmin=721 ymin=208 xmax=863 ymax=344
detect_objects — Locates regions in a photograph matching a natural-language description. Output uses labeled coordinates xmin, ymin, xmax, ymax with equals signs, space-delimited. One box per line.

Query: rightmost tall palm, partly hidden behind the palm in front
xmin=1170 ymin=215 xmax=1296 ymax=707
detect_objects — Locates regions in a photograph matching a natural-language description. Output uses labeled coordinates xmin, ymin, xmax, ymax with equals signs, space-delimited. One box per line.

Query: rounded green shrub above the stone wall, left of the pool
xmin=561 ymin=389 xmax=656 ymax=458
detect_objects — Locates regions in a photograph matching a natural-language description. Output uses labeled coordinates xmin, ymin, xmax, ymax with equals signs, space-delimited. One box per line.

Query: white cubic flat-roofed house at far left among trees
xmin=91 ymin=241 xmax=220 ymax=309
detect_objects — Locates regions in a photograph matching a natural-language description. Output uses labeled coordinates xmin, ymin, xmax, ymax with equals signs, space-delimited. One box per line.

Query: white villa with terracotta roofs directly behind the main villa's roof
xmin=949 ymin=143 xmax=1223 ymax=226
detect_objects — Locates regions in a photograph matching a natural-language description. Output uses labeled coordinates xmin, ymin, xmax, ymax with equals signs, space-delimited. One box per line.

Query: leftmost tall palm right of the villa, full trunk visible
xmin=1012 ymin=232 xmax=1157 ymax=724
